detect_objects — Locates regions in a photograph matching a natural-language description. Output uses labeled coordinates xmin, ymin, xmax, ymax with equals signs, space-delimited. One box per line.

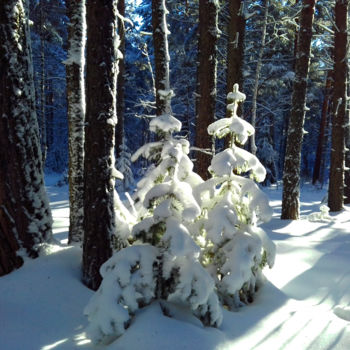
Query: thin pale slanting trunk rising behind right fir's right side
xmin=250 ymin=0 xmax=270 ymax=155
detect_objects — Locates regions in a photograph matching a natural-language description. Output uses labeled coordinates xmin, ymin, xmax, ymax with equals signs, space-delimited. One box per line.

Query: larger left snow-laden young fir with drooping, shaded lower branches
xmin=85 ymin=94 xmax=222 ymax=343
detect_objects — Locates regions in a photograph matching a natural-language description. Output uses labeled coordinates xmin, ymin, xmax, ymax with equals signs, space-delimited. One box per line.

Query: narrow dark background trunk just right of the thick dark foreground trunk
xmin=115 ymin=0 xmax=125 ymax=158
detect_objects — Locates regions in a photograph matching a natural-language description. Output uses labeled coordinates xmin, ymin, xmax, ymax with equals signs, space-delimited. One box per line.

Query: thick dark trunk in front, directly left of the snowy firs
xmin=83 ymin=0 xmax=118 ymax=290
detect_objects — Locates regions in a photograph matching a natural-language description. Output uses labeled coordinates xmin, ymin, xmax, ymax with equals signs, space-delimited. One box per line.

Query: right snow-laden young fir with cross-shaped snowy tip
xmin=193 ymin=84 xmax=275 ymax=308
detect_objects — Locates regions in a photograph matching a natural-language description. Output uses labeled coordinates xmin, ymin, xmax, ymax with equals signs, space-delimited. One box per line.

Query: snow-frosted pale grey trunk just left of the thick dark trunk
xmin=65 ymin=0 xmax=86 ymax=243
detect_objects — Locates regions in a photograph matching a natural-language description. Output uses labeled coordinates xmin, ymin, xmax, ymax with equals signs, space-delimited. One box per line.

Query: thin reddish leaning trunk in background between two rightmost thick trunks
xmin=312 ymin=71 xmax=333 ymax=185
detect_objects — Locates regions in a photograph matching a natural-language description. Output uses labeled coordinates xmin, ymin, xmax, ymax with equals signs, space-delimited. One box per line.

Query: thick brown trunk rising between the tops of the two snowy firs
xmin=194 ymin=0 xmax=218 ymax=179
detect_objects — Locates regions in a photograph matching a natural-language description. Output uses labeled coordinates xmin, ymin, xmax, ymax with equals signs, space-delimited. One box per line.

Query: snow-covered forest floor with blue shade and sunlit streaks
xmin=0 ymin=176 xmax=350 ymax=350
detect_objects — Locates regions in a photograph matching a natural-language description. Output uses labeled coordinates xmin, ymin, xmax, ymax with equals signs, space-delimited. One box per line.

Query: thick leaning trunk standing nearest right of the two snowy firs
xmin=281 ymin=0 xmax=315 ymax=220
